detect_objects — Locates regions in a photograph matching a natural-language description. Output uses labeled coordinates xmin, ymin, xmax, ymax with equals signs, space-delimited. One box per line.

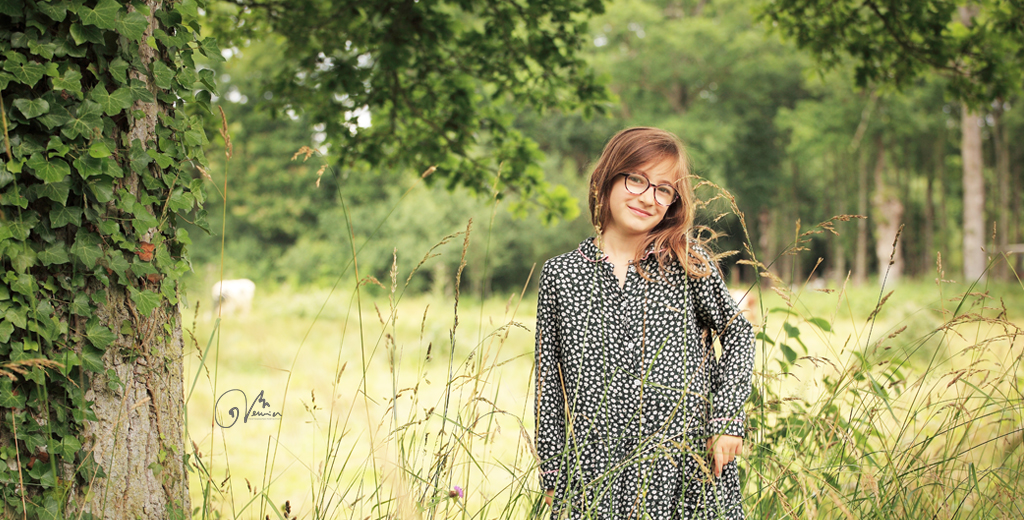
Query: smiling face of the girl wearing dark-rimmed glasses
xmin=604 ymin=159 xmax=678 ymax=236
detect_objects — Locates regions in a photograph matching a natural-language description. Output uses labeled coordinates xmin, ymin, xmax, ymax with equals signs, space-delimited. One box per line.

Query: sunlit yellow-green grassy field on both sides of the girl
xmin=183 ymin=275 xmax=1024 ymax=519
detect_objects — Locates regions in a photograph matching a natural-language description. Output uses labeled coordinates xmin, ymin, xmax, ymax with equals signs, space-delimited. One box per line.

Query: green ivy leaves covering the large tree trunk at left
xmin=0 ymin=0 xmax=220 ymax=518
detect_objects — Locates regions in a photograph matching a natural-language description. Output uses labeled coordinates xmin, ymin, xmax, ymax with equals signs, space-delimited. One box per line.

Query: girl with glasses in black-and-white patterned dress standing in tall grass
xmin=536 ymin=128 xmax=754 ymax=520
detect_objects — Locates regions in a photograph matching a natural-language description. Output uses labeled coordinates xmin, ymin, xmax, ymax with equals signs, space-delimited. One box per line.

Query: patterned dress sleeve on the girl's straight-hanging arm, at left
xmin=535 ymin=264 xmax=565 ymax=489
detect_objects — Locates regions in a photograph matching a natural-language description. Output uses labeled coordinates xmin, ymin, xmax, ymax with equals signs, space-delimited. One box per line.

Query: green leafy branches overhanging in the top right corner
xmin=764 ymin=0 xmax=1024 ymax=105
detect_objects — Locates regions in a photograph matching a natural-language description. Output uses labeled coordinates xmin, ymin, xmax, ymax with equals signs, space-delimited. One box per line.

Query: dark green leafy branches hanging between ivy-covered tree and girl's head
xmin=207 ymin=0 xmax=605 ymax=216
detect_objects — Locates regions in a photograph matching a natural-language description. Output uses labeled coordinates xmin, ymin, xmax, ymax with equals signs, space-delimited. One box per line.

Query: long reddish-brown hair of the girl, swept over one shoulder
xmin=589 ymin=127 xmax=711 ymax=277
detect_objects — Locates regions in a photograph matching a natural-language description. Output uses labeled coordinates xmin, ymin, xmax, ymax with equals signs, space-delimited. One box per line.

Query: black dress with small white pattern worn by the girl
xmin=536 ymin=237 xmax=754 ymax=520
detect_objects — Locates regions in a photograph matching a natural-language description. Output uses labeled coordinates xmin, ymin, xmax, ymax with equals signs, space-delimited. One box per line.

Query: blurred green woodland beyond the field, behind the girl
xmin=190 ymin=0 xmax=1024 ymax=296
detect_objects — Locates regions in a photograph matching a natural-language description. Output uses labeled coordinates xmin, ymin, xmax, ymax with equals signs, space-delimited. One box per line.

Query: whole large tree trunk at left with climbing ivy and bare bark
xmin=0 ymin=0 xmax=214 ymax=519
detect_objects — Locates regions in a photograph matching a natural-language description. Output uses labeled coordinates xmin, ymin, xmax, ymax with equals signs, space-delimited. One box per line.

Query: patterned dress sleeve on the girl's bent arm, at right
xmin=690 ymin=253 xmax=754 ymax=437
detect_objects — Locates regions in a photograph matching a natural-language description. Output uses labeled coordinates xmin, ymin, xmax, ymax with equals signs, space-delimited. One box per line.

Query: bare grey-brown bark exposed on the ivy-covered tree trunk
xmin=78 ymin=0 xmax=191 ymax=520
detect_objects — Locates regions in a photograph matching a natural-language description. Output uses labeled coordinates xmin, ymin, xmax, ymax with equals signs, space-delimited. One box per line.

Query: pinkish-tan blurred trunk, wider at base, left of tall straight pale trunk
xmin=871 ymin=136 xmax=903 ymax=285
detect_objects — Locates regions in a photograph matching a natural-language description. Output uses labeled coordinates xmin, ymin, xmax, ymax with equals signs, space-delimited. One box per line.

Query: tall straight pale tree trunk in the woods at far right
xmin=961 ymin=105 xmax=986 ymax=284
